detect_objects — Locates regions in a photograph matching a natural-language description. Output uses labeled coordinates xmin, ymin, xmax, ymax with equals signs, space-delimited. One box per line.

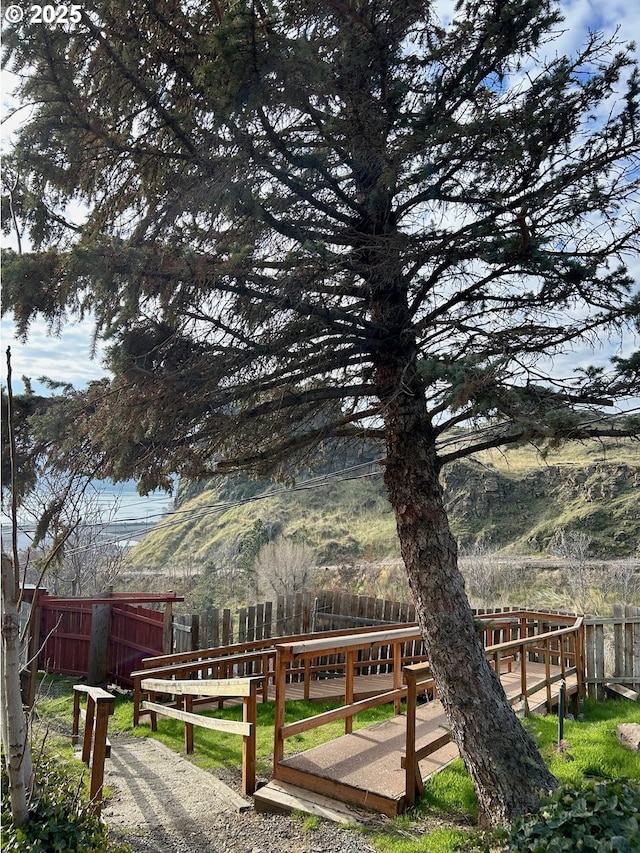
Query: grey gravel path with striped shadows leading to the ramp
xmin=102 ymin=736 xmax=374 ymax=853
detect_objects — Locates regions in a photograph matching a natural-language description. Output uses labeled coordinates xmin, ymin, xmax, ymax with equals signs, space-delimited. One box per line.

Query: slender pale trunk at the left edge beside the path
xmin=2 ymin=554 xmax=31 ymax=826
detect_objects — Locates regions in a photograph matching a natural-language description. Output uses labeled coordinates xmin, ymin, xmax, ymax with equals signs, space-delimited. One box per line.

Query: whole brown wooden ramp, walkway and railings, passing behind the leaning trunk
xmin=132 ymin=610 xmax=585 ymax=815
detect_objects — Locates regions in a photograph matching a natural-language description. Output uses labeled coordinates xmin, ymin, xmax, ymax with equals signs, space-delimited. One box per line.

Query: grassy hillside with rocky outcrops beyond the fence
xmin=130 ymin=442 xmax=640 ymax=571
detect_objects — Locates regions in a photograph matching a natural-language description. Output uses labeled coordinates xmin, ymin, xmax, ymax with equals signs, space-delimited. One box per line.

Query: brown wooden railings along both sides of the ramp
xmin=132 ymin=611 xmax=584 ymax=804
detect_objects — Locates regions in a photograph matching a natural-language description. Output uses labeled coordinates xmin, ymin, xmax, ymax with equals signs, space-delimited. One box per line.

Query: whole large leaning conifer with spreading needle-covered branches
xmin=5 ymin=0 xmax=638 ymax=823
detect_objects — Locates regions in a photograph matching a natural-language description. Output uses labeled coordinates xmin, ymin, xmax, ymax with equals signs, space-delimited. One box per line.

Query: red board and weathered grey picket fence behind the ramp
xmin=29 ymin=590 xmax=640 ymax=698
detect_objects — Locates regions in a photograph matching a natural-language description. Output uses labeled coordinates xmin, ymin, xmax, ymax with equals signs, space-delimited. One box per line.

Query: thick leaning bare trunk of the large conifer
xmin=374 ymin=291 xmax=557 ymax=826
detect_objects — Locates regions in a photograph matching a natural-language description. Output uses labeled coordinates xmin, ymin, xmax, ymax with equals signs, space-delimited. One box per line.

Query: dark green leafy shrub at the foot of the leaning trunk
xmin=507 ymin=779 xmax=640 ymax=853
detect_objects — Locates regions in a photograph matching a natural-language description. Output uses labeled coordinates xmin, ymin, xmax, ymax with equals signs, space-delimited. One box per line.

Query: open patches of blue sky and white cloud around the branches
xmin=0 ymin=0 xmax=640 ymax=393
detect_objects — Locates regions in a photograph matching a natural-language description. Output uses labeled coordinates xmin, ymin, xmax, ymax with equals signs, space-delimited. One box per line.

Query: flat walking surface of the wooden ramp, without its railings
xmin=255 ymin=663 xmax=577 ymax=817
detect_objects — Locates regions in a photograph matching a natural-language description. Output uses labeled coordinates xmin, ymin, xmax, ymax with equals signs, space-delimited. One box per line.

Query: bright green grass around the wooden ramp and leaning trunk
xmin=37 ymin=677 xmax=640 ymax=853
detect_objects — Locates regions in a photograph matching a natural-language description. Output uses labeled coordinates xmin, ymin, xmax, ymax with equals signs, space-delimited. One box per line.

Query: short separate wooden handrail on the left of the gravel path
xmin=71 ymin=684 xmax=116 ymax=815
